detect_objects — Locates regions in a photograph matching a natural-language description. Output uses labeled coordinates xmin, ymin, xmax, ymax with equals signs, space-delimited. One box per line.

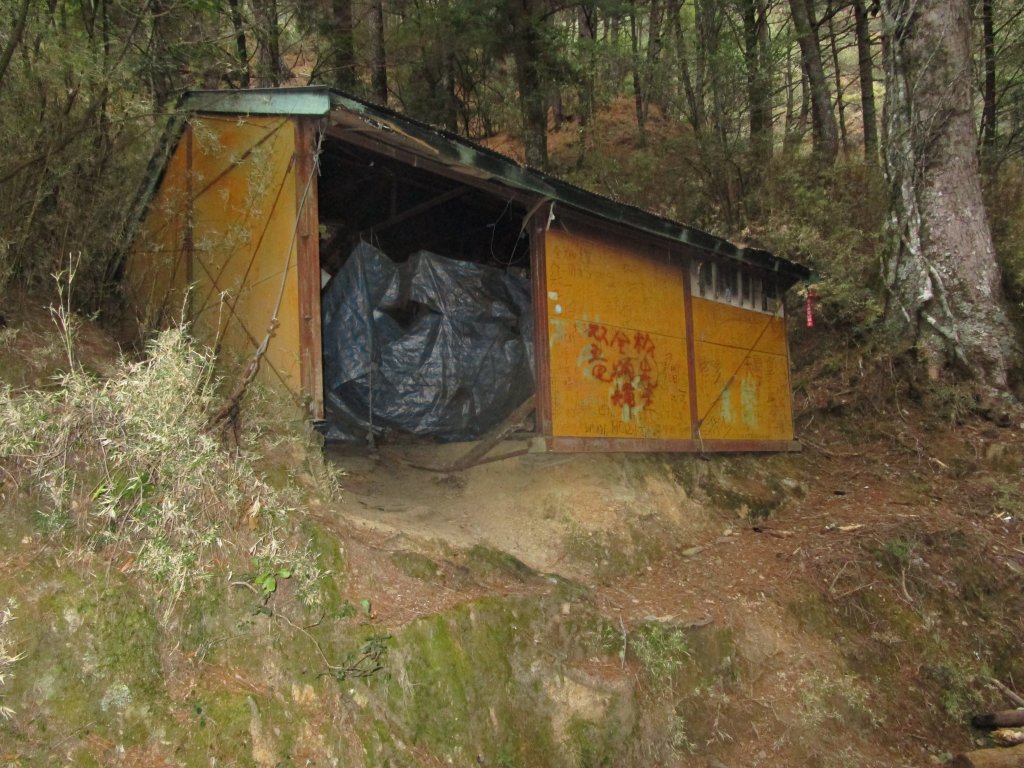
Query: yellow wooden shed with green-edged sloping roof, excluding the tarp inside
xmin=125 ymin=87 xmax=807 ymax=452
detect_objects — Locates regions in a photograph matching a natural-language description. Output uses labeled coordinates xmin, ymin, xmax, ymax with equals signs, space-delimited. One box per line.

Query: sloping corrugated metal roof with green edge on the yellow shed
xmin=178 ymin=86 xmax=810 ymax=284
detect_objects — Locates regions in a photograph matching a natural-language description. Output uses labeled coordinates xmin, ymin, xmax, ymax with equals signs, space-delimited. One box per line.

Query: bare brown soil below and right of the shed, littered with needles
xmin=315 ymin=327 xmax=1024 ymax=768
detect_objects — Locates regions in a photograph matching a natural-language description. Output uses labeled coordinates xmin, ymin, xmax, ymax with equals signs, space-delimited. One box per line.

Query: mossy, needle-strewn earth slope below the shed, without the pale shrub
xmin=0 ymin=290 xmax=1024 ymax=768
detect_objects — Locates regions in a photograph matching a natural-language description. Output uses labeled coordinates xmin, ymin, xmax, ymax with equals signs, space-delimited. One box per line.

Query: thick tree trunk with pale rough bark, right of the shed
xmin=882 ymin=0 xmax=1019 ymax=394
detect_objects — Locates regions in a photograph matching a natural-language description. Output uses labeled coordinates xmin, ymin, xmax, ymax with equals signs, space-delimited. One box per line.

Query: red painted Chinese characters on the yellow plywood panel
xmin=578 ymin=323 xmax=657 ymax=421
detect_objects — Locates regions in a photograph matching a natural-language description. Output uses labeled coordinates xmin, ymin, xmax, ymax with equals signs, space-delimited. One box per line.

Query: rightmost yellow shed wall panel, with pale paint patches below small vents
xmin=692 ymin=297 xmax=793 ymax=440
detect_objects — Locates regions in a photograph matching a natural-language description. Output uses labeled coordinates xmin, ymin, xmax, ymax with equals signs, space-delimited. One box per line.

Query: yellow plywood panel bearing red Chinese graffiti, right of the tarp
xmin=535 ymin=229 xmax=690 ymax=439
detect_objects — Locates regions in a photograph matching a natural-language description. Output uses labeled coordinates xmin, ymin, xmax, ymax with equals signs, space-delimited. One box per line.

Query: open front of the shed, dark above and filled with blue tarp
xmin=317 ymin=136 xmax=535 ymax=444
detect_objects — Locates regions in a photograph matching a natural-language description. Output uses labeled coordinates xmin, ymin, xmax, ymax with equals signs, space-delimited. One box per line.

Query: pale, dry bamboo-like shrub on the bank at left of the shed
xmin=0 ymin=322 xmax=319 ymax=610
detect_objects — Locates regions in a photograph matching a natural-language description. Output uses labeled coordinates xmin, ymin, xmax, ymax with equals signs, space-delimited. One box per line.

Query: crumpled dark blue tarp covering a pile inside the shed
xmin=321 ymin=243 xmax=534 ymax=441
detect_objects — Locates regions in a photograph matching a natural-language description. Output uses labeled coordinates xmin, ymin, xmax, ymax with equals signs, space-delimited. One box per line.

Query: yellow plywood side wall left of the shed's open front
xmin=127 ymin=116 xmax=305 ymax=403
